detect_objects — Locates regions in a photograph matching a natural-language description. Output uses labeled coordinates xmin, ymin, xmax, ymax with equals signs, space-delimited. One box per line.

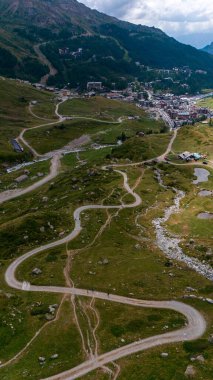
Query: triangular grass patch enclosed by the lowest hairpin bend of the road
xmin=95 ymin=300 xmax=185 ymax=353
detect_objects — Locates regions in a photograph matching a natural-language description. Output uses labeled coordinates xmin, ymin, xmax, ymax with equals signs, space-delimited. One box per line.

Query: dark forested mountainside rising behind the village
xmin=0 ymin=0 xmax=213 ymax=89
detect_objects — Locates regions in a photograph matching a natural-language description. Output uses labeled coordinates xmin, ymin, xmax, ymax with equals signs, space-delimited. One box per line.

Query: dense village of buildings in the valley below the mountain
xmin=12 ymin=76 xmax=213 ymax=129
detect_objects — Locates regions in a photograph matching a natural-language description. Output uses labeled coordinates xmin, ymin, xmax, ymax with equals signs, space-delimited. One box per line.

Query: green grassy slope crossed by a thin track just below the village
xmin=26 ymin=97 xmax=163 ymax=153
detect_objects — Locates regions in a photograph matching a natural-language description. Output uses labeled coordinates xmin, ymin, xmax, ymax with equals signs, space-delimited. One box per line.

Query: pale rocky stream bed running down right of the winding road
xmin=152 ymin=171 xmax=213 ymax=281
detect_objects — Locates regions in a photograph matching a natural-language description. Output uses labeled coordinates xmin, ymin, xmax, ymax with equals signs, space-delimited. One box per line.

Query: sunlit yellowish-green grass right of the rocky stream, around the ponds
xmin=164 ymin=126 xmax=213 ymax=265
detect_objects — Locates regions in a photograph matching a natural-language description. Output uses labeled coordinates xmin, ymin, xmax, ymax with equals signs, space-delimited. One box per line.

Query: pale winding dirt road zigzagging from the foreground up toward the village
xmin=0 ymin=104 xmax=206 ymax=380
